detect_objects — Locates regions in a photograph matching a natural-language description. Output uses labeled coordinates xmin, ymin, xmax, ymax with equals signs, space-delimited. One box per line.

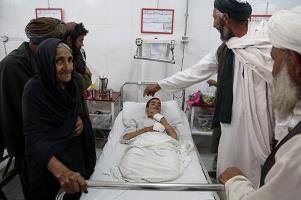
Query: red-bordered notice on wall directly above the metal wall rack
xmin=141 ymin=8 xmax=174 ymax=34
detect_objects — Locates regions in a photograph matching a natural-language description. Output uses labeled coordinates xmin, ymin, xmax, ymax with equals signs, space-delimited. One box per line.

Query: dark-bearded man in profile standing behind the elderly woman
xmin=64 ymin=22 xmax=92 ymax=115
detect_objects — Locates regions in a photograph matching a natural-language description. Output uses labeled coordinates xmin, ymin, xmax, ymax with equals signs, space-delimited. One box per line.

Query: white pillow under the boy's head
xmin=122 ymin=101 xmax=182 ymax=126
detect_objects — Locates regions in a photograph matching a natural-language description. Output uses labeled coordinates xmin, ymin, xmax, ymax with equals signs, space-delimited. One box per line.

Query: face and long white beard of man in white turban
xmin=271 ymin=47 xmax=300 ymax=119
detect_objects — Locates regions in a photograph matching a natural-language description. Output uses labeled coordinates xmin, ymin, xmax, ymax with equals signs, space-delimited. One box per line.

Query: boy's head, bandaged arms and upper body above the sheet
xmin=121 ymin=97 xmax=177 ymax=143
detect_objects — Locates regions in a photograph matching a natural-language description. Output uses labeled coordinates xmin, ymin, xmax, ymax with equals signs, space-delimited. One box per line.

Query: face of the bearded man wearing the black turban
xmin=212 ymin=8 xmax=233 ymax=41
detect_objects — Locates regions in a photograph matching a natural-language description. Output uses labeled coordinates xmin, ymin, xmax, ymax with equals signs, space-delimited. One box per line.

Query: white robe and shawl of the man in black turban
xmin=158 ymin=36 xmax=273 ymax=185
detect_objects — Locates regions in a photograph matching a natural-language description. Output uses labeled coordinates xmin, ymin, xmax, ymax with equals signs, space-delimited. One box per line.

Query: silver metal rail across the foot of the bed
xmin=56 ymin=181 xmax=224 ymax=200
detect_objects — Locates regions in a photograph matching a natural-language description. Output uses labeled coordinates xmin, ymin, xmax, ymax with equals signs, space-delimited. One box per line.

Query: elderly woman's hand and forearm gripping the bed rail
xmin=47 ymin=156 xmax=87 ymax=193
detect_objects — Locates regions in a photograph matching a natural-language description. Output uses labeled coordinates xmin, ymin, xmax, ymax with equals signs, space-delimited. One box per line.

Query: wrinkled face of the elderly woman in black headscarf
xmin=55 ymin=47 xmax=73 ymax=89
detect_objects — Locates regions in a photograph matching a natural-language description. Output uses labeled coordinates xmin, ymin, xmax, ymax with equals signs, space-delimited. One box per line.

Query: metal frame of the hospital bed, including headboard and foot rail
xmin=56 ymin=82 xmax=225 ymax=200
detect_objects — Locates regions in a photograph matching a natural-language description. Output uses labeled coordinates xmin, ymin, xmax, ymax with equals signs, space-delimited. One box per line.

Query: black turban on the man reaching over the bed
xmin=214 ymin=0 xmax=252 ymax=21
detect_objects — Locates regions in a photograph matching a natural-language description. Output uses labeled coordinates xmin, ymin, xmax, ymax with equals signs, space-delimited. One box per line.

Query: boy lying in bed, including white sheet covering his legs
xmin=113 ymin=98 xmax=193 ymax=182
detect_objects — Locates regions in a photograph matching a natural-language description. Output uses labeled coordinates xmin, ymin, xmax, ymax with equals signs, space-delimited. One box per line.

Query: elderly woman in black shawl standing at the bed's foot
xmin=22 ymin=38 xmax=96 ymax=200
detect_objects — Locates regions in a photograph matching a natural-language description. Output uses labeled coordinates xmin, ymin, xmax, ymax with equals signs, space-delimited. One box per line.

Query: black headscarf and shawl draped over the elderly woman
xmin=22 ymin=38 xmax=96 ymax=195
